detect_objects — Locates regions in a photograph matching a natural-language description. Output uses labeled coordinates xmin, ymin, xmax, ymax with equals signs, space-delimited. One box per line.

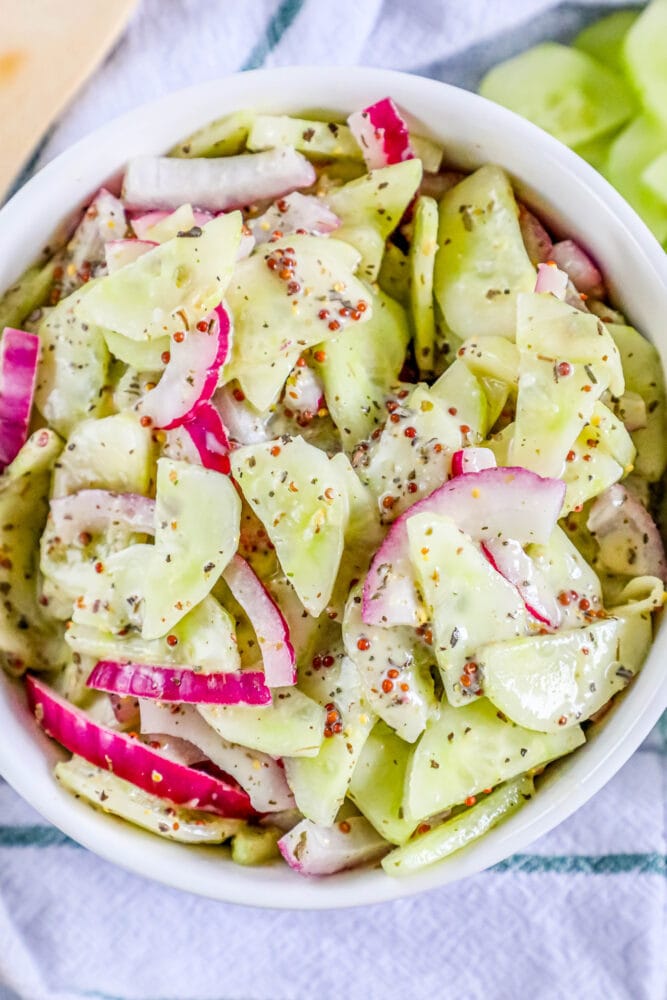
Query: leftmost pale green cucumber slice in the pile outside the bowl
xmin=479 ymin=42 xmax=636 ymax=146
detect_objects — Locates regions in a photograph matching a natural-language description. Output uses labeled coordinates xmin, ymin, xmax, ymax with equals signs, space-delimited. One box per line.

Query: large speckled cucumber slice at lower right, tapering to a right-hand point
xmin=404 ymin=698 xmax=586 ymax=824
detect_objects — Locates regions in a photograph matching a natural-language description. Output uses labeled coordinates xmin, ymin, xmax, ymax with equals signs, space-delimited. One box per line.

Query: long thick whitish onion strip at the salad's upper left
xmin=123 ymin=146 xmax=317 ymax=214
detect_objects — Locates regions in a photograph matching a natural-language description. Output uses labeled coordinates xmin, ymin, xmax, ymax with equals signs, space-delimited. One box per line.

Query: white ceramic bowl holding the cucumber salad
xmin=0 ymin=68 xmax=667 ymax=909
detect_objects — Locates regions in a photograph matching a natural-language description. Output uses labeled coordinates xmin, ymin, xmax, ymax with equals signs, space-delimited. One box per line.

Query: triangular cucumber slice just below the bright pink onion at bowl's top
xmin=327 ymin=160 xmax=422 ymax=281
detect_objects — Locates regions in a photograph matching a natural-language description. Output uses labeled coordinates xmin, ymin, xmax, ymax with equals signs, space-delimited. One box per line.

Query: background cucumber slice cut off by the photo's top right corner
xmin=624 ymin=0 xmax=667 ymax=125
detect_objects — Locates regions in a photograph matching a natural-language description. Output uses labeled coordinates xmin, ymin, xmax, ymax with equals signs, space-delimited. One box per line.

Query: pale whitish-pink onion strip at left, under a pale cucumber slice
xmin=51 ymin=490 xmax=155 ymax=545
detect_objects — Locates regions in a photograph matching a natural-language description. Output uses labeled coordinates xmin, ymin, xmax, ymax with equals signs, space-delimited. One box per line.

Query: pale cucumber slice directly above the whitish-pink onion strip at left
xmin=53 ymin=413 xmax=155 ymax=497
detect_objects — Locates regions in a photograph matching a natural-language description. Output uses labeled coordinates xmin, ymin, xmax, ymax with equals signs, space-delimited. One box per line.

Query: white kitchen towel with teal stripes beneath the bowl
xmin=0 ymin=0 xmax=667 ymax=1000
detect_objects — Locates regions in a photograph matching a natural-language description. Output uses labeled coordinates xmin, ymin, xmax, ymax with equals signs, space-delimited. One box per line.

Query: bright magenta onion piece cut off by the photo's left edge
xmin=0 ymin=326 xmax=39 ymax=470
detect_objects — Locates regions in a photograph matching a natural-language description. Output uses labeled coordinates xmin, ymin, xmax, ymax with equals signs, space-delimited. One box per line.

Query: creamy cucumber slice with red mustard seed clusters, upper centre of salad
xmin=224 ymin=234 xmax=372 ymax=411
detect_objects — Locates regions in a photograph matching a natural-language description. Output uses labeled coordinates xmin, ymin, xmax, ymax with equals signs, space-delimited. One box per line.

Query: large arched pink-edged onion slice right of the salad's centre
xmin=362 ymin=467 xmax=565 ymax=626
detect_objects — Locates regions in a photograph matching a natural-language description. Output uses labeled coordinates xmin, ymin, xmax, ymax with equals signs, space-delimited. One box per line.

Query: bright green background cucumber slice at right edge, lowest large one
xmin=604 ymin=114 xmax=667 ymax=242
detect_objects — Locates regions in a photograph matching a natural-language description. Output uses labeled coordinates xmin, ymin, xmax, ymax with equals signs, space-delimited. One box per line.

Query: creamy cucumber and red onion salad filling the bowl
xmin=0 ymin=99 xmax=667 ymax=876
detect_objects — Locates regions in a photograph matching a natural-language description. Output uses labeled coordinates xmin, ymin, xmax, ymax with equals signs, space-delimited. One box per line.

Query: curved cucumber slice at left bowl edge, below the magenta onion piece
xmin=0 ymin=430 xmax=67 ymax=674
